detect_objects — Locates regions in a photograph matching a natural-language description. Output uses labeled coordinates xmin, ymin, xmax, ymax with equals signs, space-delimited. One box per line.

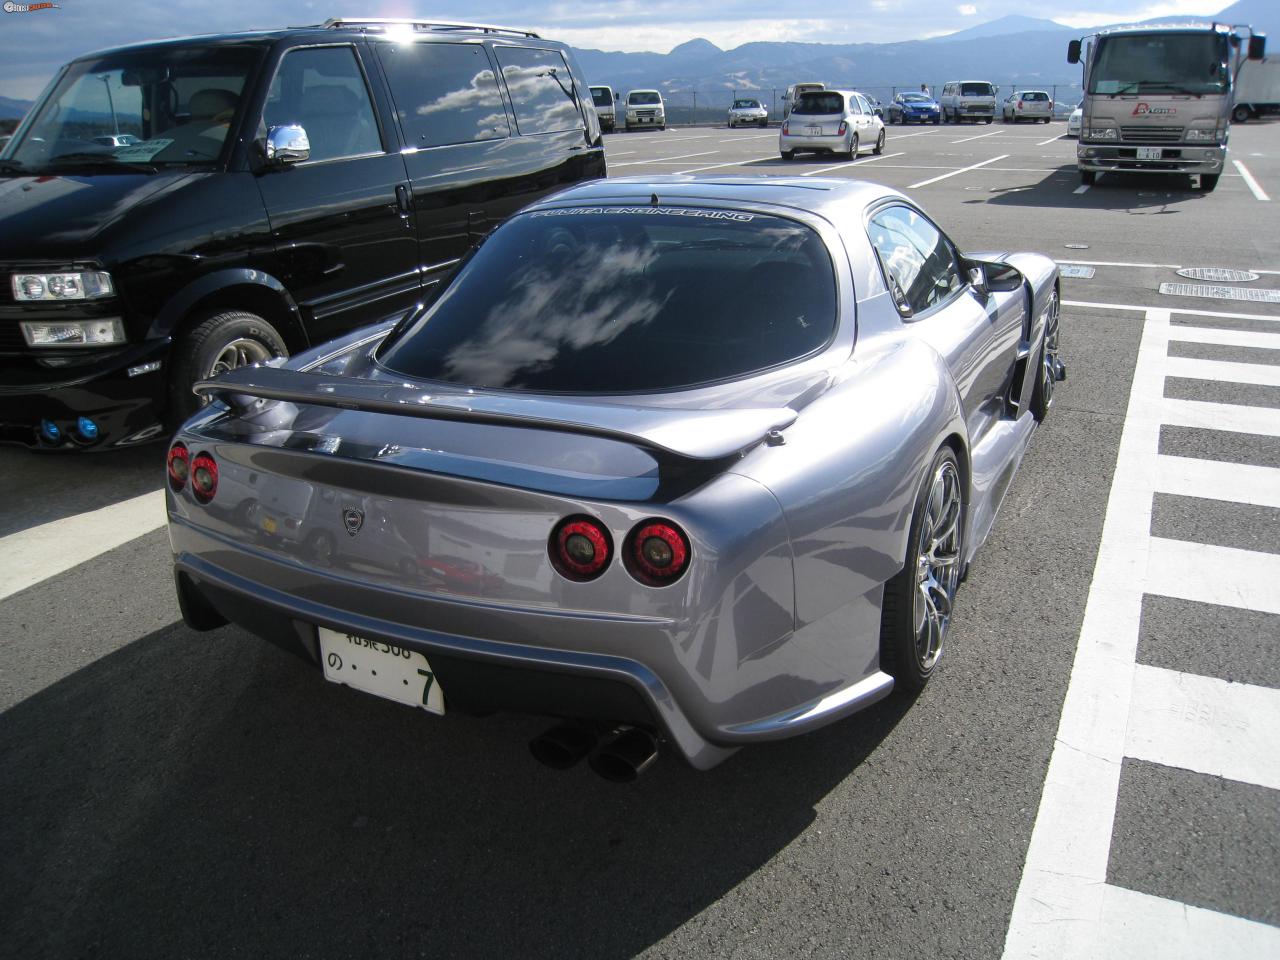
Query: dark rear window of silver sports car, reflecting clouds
xmin=378 ymin=205 xmax=836 ymax=394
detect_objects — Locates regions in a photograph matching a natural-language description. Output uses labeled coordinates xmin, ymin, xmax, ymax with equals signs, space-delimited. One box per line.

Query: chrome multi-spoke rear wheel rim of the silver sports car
xmin=913 ymin=461 xmax=964 ymax=671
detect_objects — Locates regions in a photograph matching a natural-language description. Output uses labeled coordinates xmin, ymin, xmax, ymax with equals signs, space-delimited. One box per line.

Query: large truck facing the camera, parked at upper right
xmin=1066 ymin=23 xmax=1266 ymax=193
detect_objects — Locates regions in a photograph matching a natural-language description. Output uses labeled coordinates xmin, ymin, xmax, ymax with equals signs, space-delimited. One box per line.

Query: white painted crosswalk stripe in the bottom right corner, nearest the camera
xmin=1090 ymin=884 xmax=1280 ymax=960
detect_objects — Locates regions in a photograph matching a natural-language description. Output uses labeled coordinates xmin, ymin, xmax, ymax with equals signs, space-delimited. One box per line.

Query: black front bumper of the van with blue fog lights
xmin=0 ymin=340 xmax=169 ymax=451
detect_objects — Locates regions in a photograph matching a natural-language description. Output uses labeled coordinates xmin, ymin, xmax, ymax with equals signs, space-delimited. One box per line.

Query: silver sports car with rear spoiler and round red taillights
xmin=168 ymin=177 xmax=1064 ymax=780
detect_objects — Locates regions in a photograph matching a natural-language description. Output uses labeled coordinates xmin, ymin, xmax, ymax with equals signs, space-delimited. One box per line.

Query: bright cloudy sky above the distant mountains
xmin=0 ymin=0 xmax=1230 ymax=100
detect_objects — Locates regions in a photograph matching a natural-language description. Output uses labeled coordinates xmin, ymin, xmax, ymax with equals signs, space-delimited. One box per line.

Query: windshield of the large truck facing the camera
xmin=1089 ymin=33 xmax=1230 ymax=95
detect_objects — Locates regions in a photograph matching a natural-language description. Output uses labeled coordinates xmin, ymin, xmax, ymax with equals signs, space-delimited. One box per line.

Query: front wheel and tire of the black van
xmin=169 ymin=310 xmax=289 ymax=426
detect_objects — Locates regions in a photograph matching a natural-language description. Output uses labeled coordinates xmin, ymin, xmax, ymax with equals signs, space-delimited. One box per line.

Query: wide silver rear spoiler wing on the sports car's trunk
xmin=195 ymin=366 xmax=796 ymax=461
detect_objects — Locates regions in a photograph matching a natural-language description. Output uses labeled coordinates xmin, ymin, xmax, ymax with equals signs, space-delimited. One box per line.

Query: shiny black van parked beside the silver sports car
xmin=0 ymin=19 xmax=605 ymax=449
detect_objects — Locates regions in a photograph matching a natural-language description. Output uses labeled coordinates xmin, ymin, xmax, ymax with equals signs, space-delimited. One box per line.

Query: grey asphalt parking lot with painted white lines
xmin=0 ymin=122 xmax=1280 ymax=957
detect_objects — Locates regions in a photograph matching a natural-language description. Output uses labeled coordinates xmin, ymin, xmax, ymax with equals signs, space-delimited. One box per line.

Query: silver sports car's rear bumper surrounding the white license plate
xmin=169 ymin=515 xmax=893 ymax=769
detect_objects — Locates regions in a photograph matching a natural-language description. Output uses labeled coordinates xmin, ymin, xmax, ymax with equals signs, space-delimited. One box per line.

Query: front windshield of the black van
xmin=4 ymin=45 xmax=262 ymax=173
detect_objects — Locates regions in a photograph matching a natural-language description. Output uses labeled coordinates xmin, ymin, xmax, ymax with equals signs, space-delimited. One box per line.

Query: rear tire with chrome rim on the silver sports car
xmin=879 ymin=445 xmax=965 ymax=692
